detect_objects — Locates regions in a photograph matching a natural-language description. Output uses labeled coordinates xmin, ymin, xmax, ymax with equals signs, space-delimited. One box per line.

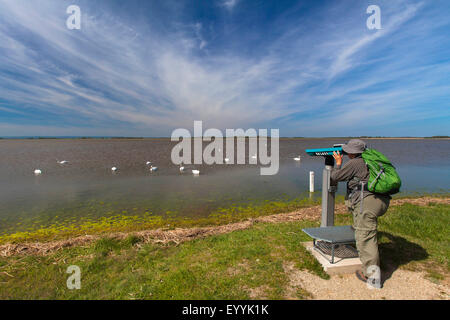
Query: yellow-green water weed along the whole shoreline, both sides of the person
xmin=0 ymin=194 xmax=448 ymax=243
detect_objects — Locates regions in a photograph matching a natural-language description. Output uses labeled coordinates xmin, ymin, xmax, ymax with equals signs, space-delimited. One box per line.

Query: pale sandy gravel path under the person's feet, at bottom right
xmin=284 ymin=263 xmax=450 ymax=300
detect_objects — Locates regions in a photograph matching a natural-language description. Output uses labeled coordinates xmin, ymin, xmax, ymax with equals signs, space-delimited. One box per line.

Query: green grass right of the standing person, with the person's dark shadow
xmin=337 ymin=203 xmax=450 ymax=280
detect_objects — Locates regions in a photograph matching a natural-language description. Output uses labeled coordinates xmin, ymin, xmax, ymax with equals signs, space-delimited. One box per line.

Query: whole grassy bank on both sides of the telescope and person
xmin=0 ymin=203 xmax=450 ymax=299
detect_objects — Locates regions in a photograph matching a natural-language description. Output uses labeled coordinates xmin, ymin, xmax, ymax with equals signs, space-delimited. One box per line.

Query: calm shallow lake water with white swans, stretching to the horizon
xmin=0 ymin=139 xmax=450 ymax=234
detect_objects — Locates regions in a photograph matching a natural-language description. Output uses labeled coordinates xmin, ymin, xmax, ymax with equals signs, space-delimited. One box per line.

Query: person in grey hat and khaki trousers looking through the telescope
xmin=331 ymin=139 xmax=391 ymax=282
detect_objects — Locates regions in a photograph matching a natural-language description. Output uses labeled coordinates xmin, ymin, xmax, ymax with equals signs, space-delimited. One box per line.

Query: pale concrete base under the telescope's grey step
xmin=302 ymin=241 xmax=362 ymax=275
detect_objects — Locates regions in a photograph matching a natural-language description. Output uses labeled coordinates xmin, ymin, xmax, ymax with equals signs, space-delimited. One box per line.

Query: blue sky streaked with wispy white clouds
xmin=0 ymin=0 xmax=450 ymax=137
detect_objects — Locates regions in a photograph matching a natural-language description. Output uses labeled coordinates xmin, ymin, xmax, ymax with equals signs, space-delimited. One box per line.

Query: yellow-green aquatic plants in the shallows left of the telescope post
xmin=0 ymin=197 xmax=320 ymax=243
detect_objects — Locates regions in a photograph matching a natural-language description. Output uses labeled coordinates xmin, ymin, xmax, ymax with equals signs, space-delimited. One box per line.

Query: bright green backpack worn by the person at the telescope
xmin=362 ymin=149 xmax=402 ymax=194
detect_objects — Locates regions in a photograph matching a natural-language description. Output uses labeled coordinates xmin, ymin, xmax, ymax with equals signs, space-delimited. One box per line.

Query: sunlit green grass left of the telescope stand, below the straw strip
xmin=0 ymin=222 xmax=327 ymax=299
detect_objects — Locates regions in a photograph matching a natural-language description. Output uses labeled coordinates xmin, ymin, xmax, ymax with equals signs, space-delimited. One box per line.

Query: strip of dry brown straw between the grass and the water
xmin=0 ymin=197 xmax=450 ymax=257
